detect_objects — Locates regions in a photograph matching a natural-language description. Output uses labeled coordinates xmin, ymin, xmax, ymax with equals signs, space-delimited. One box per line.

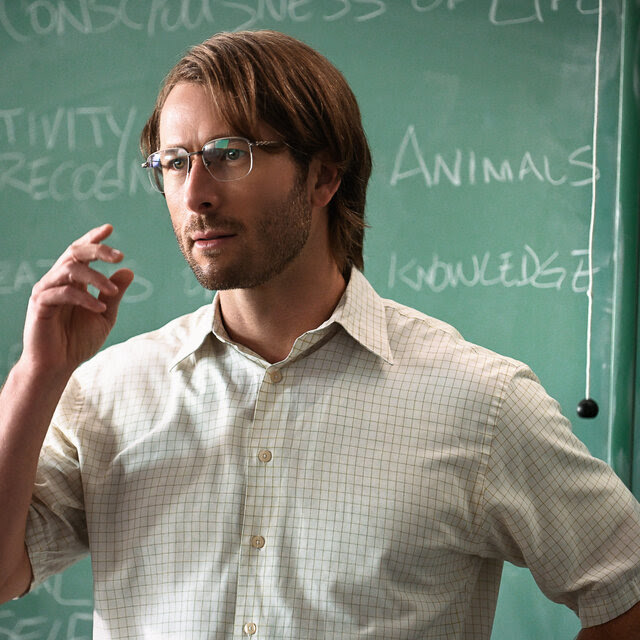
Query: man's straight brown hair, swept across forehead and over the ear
xmin=140 ymin=30 xmax=371 ymax=275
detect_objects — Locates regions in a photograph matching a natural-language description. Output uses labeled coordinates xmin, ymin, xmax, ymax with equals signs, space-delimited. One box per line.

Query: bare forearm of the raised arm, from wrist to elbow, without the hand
xmin=0 ymin=362 xmax=68 ymax=600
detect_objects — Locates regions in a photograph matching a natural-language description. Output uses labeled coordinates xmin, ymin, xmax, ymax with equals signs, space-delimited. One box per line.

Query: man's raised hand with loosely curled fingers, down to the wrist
xmin=21 ymin=224 xmax=133 ymax=375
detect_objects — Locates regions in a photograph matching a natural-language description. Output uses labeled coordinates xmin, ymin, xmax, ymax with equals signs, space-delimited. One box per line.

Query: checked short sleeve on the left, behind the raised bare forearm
xmin=26 ymin=379 xmax=88 ymax=588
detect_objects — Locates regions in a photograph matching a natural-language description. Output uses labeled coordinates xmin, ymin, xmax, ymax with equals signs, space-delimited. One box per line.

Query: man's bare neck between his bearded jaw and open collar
xmin=219 ymin=259 xmax=346 ymax=363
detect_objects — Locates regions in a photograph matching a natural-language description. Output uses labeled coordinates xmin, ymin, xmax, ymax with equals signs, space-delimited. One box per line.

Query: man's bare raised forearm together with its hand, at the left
xmin=0 ymin=225 xmax=133 ymax=599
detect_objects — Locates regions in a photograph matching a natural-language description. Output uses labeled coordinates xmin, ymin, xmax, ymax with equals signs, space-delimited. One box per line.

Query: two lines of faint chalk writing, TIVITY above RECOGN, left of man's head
xmin=0 ymin=106 xmax=152 ymax=202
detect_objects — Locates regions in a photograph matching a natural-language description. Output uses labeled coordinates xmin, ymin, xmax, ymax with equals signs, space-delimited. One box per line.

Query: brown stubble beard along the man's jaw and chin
xmin=174 ymin=174 xmax=311 ymax=291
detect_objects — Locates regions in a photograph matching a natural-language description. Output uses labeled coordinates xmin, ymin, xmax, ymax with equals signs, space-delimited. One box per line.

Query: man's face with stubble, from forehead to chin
xmin=160 ymin=83 xmax=312 ymax=289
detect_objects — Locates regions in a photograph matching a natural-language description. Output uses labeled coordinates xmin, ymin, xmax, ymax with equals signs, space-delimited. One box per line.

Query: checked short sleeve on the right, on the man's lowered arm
xmin=483 ymin=367 xmax=640 ymax=626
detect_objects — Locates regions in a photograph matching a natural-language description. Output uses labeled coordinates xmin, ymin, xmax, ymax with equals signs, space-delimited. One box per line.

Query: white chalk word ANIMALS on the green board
xmin=390 ymin=125 xmax=600 ymax=188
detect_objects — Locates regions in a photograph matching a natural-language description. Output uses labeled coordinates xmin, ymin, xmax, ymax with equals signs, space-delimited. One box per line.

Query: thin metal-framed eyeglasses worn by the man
xmin=142 ymin=137 xmax=286 ymax=193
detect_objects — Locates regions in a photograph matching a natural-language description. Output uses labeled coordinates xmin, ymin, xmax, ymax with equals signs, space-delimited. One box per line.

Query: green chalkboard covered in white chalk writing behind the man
xmin=0 ymin=0 xmax=640 ymax=640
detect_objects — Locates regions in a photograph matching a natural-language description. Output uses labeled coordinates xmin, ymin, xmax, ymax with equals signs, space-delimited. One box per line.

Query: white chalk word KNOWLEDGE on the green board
xmin=388 ymin=244 xmax=599 ymax=293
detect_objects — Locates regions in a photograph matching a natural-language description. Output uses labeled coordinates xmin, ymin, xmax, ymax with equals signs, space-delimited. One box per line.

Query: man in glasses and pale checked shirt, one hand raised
xmin=0 ymin=32 xmax=640 ymax=640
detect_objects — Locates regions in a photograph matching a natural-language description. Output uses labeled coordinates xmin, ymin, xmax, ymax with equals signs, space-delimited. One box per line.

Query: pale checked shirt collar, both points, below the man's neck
xmin=171 ymin=269 xmax=393 ymax=369
